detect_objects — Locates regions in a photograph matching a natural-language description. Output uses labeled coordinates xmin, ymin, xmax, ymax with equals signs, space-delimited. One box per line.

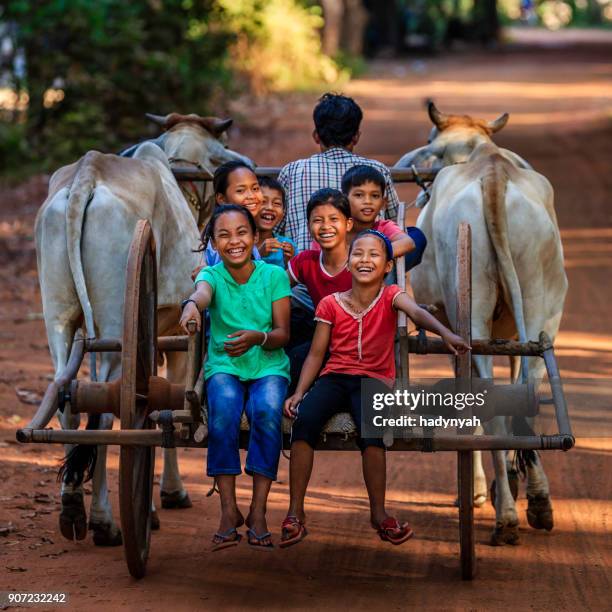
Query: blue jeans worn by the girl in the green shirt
xmin=206 ymin=373 xmax=288 ymax=480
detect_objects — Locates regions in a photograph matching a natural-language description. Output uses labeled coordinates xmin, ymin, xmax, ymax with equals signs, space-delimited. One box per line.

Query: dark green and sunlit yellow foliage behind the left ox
xmin=0 ymin=0 xmax=348 ymax=171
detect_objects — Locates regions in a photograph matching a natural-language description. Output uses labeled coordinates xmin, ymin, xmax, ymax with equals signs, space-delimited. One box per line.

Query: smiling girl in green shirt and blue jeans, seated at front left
xmin=181 ymin=204 xmax=291 ymax=549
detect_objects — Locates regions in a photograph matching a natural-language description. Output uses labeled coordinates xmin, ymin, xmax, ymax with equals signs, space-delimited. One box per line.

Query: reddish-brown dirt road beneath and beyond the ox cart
xmin=0 ymin=32 xmax=612 ymax=610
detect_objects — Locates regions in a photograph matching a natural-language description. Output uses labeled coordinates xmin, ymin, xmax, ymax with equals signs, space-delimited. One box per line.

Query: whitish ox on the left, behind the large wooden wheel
xmin=35 ymin=115 xmax=249 ymax=545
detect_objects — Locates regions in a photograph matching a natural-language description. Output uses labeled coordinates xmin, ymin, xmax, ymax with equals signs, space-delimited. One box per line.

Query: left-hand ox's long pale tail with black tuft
xmin=58 ymin=151 xmax=101 ymax=486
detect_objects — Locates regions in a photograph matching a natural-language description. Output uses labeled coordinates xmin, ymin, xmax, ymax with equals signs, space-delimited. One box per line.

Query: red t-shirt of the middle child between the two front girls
xmin=287 ymin=250 xmax=353 ymax=308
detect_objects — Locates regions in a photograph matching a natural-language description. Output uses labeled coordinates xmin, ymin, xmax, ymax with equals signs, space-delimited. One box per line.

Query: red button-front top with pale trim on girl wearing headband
xmin=315 ymin=285 xmax=402 ymax=382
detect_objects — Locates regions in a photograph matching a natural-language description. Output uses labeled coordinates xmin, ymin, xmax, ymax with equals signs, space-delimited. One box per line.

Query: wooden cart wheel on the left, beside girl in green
xmin=119 ymin=221 xmax=157 ymax=578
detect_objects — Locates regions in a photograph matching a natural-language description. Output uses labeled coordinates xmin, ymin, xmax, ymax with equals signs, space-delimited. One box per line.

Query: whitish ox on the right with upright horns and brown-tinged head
xmin=396 ymin=102 xmax=567 ymax=544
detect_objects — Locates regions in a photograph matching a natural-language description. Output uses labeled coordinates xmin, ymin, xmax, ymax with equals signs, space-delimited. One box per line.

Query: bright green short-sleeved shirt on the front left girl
xmin=195 ymin=261 xmax=291 ymax=381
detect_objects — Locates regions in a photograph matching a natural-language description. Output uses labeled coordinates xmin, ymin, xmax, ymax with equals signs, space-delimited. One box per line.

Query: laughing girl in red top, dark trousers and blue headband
xmin=280 ymin=230 xmax=470 ymax=547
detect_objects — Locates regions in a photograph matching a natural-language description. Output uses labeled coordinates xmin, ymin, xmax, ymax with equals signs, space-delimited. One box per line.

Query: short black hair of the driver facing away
xmin=312 ymin=93 xmax=363 ymax=147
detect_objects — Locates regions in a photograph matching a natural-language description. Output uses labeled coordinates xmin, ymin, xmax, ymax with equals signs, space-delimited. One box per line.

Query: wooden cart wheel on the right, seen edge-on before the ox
xmin=455 ymin=223 xmax=476 ymax=580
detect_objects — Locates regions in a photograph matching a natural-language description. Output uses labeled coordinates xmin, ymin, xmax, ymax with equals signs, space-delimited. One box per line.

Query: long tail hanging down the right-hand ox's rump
xmin=481 ymin=153 xmax=528 ymax=382
